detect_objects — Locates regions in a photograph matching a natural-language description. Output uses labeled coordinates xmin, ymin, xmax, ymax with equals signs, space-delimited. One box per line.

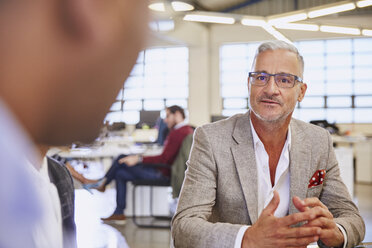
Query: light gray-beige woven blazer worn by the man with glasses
xmin=172 ymin=113 xmax=365 ymax=248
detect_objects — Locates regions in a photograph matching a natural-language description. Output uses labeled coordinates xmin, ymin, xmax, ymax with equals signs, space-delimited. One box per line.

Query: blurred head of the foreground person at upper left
xmin=0 ymin=0 xmax=147 ymax=145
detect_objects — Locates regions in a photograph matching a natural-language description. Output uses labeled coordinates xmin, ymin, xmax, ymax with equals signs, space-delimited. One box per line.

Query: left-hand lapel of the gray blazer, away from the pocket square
xmin=231 ymin=113 xmax=258 ymax=224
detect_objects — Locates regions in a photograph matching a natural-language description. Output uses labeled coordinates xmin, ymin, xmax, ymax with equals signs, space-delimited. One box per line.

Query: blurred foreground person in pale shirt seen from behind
xmin=0 ymin=0 xmax=147 ymax=248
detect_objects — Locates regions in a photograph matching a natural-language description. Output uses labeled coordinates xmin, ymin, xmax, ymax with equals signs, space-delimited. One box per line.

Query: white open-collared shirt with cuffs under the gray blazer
xmin=234 ymin=117 xmax=347 ymax=248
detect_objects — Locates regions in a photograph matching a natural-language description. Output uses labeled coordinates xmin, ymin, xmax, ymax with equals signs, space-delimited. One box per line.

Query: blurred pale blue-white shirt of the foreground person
xmin=0 ymin=98 xmax=62 ymax=248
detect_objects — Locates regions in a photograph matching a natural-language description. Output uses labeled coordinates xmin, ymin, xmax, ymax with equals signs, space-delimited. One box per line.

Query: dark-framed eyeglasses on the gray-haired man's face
xmin=249 ymin=72 xmax=302 ymax=88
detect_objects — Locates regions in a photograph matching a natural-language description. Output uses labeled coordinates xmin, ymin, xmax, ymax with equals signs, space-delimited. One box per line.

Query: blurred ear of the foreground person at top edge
xmin=56 ymin=0 xmax=96 ymax=39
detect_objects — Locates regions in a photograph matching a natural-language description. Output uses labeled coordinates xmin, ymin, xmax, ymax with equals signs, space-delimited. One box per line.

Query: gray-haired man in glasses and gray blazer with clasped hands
xmin=172 ymin=41 xmax=365 ymax=247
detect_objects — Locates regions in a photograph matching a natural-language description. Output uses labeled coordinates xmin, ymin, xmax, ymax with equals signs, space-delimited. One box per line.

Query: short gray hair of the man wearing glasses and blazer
xmin=252 ymin=40 xmax=305 ymax=77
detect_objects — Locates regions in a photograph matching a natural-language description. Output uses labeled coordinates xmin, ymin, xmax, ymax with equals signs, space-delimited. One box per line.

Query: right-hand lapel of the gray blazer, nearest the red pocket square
xmin=289 ymin=121 xmax=311 ymax=214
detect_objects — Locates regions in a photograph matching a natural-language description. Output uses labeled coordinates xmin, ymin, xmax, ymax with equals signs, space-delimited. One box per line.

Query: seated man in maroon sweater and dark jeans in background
xmin=96 ymin=105 xmax=193 ymax=221
